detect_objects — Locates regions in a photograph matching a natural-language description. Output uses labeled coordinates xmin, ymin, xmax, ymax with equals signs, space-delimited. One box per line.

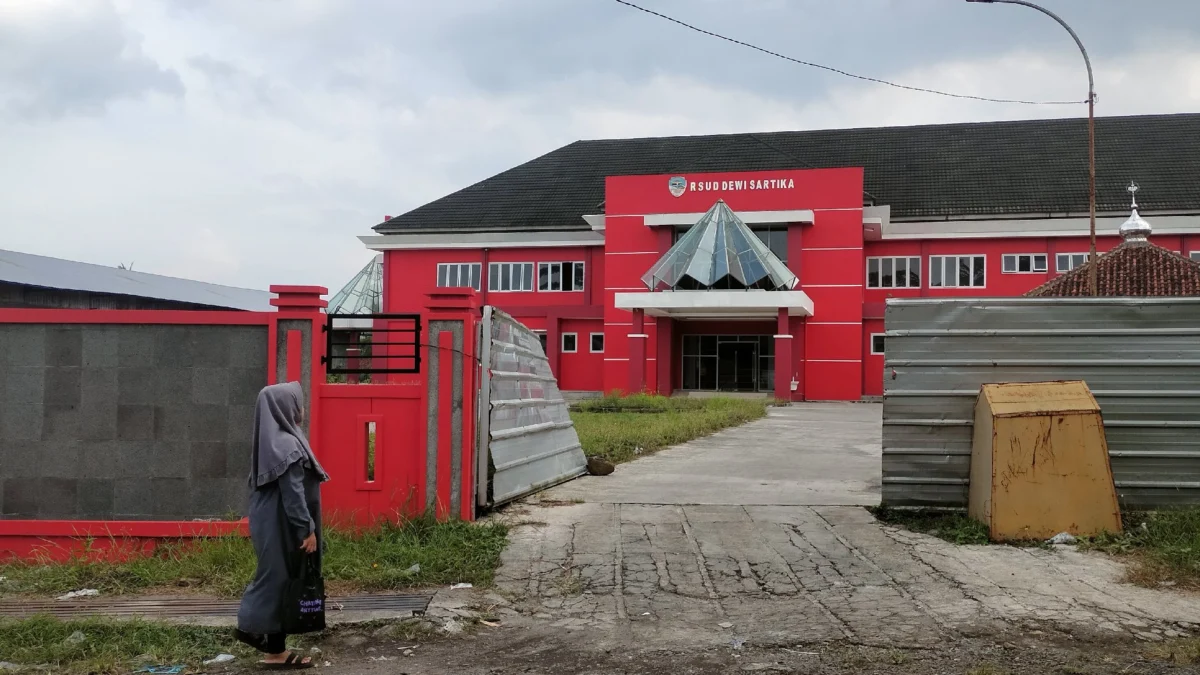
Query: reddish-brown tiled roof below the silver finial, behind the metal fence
xmin=1025 ymin=241 xmax=1200 ymax=298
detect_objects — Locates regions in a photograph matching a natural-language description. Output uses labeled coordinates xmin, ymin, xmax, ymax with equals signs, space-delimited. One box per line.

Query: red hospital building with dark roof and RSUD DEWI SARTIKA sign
xmin=361 ymin=114 xmax=1200 ymax=400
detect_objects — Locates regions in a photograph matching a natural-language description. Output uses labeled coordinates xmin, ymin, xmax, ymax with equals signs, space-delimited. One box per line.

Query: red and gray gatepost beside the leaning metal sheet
xmin=422 ymin=288 xmax=480 ymax=520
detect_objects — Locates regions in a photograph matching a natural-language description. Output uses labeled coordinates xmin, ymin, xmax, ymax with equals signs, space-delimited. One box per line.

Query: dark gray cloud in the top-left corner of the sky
xmin=0 ymin=0 xmax=184 ymax=120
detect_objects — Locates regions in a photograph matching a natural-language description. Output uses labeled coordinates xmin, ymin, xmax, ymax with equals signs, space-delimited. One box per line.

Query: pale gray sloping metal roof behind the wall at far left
xmin=0 ymin=250 xmax=275 ymax=311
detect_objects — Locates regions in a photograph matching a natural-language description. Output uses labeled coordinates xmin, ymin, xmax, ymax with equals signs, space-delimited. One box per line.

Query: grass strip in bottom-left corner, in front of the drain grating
xmin=0 ymin=616 xmax=252 ymax=673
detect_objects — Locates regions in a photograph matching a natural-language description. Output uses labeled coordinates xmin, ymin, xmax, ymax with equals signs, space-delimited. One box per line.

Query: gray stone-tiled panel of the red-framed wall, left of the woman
xmin=0 ymin=324 xmax=268 ymax=520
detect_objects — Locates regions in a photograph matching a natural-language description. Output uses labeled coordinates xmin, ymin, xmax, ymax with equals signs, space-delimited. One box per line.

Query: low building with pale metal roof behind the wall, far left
xmin=0 ymin=250 xmax=274 ymax=311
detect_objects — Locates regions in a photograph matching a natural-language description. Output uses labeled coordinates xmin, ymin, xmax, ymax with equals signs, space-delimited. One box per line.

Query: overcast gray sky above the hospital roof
xmin=0 ymin=0 xmax=1200 ymax=289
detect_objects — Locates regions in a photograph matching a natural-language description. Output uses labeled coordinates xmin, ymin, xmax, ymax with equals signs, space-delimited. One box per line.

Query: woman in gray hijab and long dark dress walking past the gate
xmin=234 ymin=382 xmax=329 ymax=670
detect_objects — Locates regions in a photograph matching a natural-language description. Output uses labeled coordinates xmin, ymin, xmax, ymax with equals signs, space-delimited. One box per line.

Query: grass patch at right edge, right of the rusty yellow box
xmin=1080 ymin=507 xmax=1200 ymax=590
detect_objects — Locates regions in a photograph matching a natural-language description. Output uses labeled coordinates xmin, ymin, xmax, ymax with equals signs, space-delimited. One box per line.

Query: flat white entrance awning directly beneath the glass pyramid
xmin=616 ymin=291 xmax=812 ymax=318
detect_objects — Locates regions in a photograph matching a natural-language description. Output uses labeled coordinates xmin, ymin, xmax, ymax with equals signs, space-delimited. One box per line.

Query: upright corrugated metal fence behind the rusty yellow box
xmin=883 ymin=298 xmax=1200 ymax=508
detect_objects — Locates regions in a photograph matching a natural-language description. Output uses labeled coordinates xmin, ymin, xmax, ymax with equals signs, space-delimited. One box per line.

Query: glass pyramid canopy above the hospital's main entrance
xmin=642 ymin=199 xmax=798 ymax=291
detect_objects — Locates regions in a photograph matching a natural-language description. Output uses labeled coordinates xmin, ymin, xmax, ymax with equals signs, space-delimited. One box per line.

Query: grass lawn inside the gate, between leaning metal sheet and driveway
xmin=571 ymin=394 xmax=770 ymax=464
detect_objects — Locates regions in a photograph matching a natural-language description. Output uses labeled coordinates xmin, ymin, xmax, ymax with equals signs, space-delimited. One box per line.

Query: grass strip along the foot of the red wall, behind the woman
xmin=0 ymin=518 xmax=508 ymax=595
